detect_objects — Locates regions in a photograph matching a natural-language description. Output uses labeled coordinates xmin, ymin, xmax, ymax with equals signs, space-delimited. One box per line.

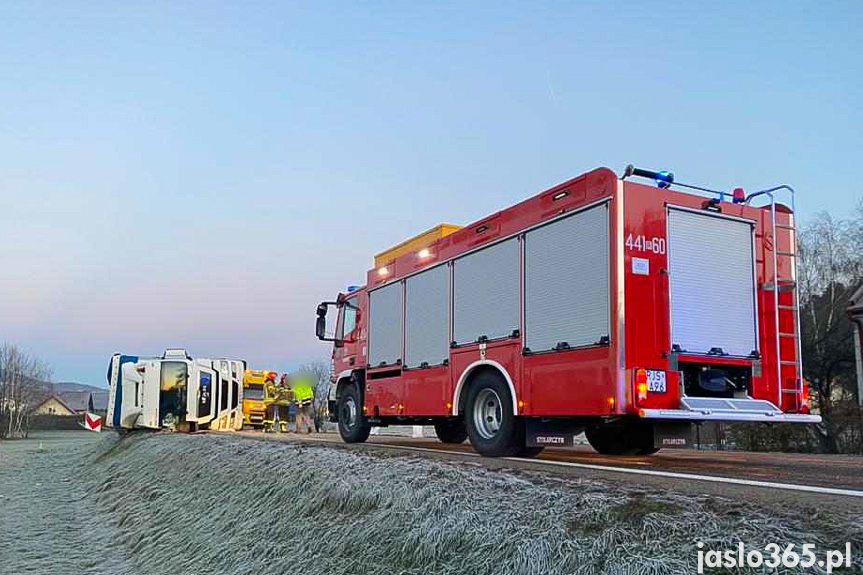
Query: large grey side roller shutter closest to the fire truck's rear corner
xmin=524 ymin=204 xmax=609 ymax=352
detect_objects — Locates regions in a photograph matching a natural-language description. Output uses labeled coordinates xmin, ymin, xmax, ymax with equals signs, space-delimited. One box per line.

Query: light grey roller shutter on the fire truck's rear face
xmin=668 ymin=208 xmax=758 ymax=356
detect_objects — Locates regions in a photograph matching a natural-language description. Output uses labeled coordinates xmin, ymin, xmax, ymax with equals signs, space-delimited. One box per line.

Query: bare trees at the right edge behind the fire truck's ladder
xmin=798 ymin=207 xmax=863 ymax=453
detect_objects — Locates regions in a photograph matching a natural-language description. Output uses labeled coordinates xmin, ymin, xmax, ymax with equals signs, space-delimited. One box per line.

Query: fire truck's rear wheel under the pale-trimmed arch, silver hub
xmin=464 ymin=371 xmax=524 ymax=457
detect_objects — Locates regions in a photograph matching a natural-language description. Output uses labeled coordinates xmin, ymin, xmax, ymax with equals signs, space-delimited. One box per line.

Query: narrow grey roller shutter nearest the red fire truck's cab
xmin=369 ymin=282 xmax=403 ymax=367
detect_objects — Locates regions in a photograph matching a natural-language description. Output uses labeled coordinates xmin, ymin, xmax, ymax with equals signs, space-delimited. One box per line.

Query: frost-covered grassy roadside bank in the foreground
xmin=0 ymin=434 xmax=863 ymax=575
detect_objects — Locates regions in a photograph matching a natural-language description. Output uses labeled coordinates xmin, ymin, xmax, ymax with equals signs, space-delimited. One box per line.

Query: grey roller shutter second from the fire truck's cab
xmin=405 ymin=265 xmax=449 ymax=367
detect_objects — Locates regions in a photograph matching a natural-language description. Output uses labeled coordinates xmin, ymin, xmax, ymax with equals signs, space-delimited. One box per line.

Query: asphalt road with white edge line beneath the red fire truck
xmin=226 ymin=431 xmax=863 ymax=513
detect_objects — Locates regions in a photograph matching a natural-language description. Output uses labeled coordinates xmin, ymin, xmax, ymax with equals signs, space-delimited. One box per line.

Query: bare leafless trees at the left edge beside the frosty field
xmin=0 ymin=343 xmax=51 ymax=439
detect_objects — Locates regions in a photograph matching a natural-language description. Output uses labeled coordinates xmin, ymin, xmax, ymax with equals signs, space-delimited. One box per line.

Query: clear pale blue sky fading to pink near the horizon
xmin=0 ymin=0 xmax=863 ymax=385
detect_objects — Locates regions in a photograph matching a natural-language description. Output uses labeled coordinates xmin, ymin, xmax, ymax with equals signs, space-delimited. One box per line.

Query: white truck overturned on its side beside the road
xmin=105 ymin=349 xmax=246 ymax=431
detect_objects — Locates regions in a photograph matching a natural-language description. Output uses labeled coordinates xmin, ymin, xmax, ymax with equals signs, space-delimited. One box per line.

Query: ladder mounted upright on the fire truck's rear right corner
xmin=746 ymin=185 xmax=803 ymax=411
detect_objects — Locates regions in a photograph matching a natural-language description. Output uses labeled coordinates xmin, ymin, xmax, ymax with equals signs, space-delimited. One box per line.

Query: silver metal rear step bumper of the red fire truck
xmin=638 ymin=396 xmax=821 ymax=423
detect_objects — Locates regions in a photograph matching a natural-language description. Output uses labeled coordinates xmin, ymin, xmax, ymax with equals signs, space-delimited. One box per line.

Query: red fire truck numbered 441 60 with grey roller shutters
xmin=316 ymin=166 xmax=820 ymax=456
